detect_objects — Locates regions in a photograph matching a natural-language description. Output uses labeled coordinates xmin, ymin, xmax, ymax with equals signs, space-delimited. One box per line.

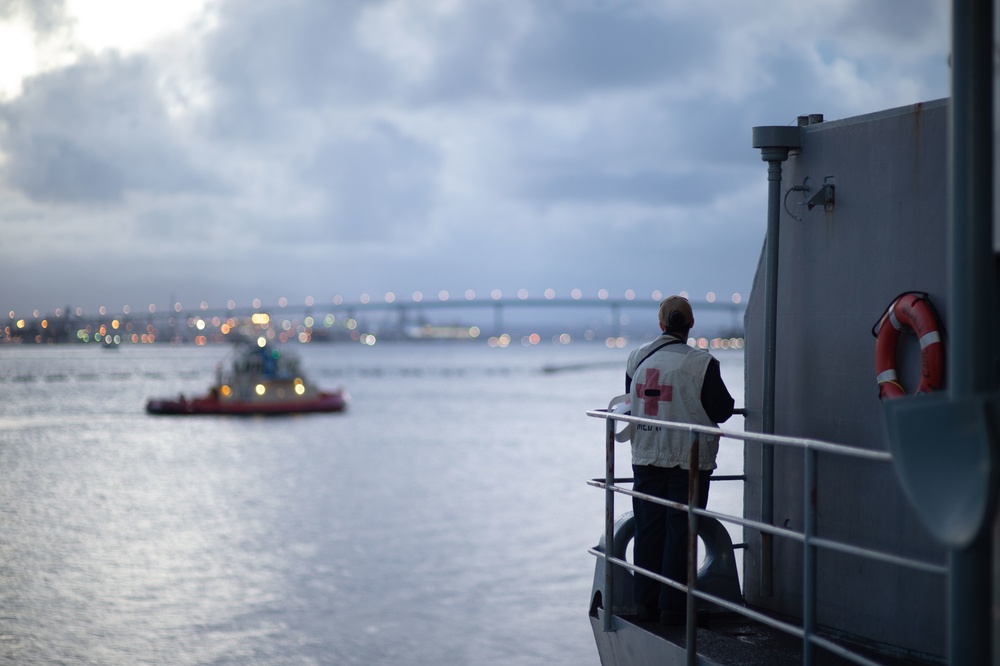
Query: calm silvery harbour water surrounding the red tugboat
xmin=0 ymin=343 xmax=743 ymax=665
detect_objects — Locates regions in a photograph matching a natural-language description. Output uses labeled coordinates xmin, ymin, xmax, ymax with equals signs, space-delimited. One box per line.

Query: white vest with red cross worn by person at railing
xmin=627 ymin=336 xmax=719 ymax=470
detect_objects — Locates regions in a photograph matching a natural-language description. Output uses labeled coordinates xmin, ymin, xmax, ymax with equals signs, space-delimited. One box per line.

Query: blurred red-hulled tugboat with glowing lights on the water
xmin=146 ymin=337 xmax=348 ymax=416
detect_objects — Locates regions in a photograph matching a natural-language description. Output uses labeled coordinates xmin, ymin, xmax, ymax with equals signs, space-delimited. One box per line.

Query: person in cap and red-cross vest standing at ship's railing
xmin=625 ymin=296 xmax=733 ymax=624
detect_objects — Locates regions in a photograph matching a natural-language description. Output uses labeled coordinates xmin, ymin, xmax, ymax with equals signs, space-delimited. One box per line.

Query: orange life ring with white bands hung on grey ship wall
xmin=872 ymin=292 xmax=944 ymax=400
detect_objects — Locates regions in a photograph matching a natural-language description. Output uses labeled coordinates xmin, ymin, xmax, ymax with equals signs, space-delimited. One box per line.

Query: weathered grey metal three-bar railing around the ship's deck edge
xmin=587 ymin=410 xmax=948 ymax=666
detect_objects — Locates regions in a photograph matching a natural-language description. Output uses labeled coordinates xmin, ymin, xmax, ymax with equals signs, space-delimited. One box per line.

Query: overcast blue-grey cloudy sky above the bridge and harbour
xmin=0 ymin=0 xmax=949 ymax=315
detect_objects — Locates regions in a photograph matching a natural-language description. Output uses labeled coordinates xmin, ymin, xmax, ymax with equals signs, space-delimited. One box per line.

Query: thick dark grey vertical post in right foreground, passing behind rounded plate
xmin=948 ymin=0 xmax=997 ymax=664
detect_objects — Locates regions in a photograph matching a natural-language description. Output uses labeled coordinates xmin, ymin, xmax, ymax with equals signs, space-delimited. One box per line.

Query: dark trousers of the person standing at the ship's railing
xmin=632 ymin=465 xmax=712 ymax=615
